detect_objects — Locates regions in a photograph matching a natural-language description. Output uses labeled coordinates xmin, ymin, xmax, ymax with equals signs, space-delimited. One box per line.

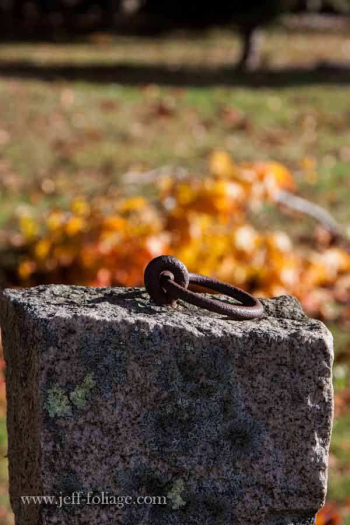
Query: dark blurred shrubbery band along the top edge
xmin=0 ymin=0 xmax=350 ymax=33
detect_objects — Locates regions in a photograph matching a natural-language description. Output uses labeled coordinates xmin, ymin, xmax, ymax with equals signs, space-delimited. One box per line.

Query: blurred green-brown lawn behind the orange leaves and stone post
xmin=0 ymin=25 xmax=350 ymax=524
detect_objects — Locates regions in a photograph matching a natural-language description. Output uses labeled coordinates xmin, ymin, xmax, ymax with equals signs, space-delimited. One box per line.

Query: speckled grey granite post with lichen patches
xmin=0 ymin=286 xmax=333 ymax=525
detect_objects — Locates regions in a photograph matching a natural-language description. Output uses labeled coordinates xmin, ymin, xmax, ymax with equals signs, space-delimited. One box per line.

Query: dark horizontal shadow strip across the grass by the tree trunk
xmin=0 ymin=60 xmax=350 ymax=88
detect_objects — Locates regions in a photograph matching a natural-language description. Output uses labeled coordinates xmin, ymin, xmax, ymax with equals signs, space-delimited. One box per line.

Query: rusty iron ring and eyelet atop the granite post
xmin=144 ymin=255 xmax=264 ymax=321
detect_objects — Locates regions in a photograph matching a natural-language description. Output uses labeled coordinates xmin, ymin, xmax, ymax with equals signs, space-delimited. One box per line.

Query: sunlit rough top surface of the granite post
xmin=0 ymin=285 xmax=332 ymax=338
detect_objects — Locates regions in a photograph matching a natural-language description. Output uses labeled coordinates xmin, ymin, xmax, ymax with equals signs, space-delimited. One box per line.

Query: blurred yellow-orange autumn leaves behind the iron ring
xmin=18 ymin=151 xmax=350 ymax=318
